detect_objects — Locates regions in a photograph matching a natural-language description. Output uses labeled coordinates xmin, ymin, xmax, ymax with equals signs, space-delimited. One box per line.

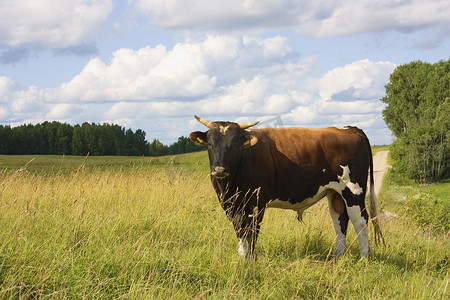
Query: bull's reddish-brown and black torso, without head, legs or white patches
xmin=236 ymin=128 xmax=370 ymax=203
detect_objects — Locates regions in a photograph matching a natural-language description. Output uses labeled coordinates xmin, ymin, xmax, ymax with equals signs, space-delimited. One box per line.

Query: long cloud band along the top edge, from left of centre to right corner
xmin=131 ymin=0 xmax=450 ymax=37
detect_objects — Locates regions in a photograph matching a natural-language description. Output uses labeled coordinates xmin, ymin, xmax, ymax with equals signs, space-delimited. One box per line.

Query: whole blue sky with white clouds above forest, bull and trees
xmin=0 ymin=0 xmax=450 ymax=144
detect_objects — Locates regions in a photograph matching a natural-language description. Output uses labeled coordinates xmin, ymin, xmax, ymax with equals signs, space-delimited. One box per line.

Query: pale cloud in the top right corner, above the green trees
xmin=299 ymin=0 xmax=450 ymax=37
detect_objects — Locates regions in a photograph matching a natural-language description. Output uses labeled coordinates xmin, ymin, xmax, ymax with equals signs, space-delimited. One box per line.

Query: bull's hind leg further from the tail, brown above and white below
xmin=327 ymin=193 xmax=349 ymax=257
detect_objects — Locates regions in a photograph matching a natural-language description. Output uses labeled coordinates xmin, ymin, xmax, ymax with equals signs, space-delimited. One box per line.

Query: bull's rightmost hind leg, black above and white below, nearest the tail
xmin=344 ymin=189 xmax=369 ymax=257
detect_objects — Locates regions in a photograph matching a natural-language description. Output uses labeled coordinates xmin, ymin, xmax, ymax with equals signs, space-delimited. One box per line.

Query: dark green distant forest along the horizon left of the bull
xmin=0 ymin=122 xmax=206 ymax=156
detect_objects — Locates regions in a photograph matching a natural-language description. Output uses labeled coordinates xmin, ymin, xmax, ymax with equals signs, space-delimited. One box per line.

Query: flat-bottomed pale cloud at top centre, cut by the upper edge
xmin=133 ymin=0 xmax=298 ymax=30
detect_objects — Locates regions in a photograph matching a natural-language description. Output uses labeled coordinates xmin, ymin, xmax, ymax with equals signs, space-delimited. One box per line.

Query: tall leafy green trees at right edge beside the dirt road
xmin=381 ymin=60 xmax=450 ymax=183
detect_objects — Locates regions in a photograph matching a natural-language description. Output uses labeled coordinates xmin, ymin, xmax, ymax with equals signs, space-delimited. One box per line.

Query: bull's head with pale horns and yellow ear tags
xmin=189 ymin=116 xmax=259 ymax=179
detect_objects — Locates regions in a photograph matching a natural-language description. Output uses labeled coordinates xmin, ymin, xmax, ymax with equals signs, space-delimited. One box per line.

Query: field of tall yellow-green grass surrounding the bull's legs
xmin=0 ymin=152 xmax=450 ymax=299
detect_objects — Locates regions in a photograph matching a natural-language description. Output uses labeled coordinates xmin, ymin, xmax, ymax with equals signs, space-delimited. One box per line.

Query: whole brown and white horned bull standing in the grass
xmin=189 ymin=116 xmax=382 ymax=258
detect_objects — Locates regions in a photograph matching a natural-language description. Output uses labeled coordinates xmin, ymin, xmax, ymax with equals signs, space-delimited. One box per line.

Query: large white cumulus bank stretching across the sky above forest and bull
xmin=0 ymin=35 xmax=395 ymax=141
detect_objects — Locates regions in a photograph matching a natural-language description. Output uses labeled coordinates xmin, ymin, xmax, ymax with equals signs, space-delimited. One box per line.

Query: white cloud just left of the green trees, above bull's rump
xmin=283 ymin=59 xmax=396 ymax=129
